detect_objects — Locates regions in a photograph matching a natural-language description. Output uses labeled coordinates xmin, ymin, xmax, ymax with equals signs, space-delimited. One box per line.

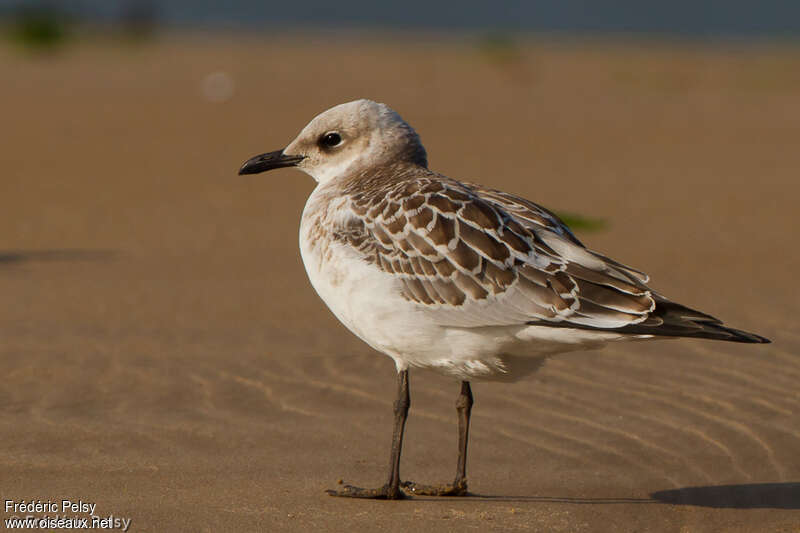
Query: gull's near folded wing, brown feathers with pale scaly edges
xmin=340 ymin=172 xmax=759 ymax=342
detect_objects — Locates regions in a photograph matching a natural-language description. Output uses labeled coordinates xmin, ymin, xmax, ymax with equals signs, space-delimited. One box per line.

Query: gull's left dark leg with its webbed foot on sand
xmin=325 ymin=370 xmax=411 ymax=500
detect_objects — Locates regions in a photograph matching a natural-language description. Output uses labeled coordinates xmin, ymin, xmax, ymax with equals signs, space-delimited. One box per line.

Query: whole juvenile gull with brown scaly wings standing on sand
xmin=239 ymin=100 xmax=769 ymax=499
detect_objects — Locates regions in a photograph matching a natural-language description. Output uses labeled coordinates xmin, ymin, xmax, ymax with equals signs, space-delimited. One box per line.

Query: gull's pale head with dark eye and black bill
xmin=239 ymin=100 xmax=428 ymax=183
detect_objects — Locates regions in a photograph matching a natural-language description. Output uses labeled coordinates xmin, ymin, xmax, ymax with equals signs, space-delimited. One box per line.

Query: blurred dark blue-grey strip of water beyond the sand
xmin=7 ymin=0 xmax=800 ymax=34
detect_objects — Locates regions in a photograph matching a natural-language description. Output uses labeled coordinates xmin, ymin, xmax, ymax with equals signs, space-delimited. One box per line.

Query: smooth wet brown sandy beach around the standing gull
xmin=0 ymin=34 xmax=800 ymax=532
